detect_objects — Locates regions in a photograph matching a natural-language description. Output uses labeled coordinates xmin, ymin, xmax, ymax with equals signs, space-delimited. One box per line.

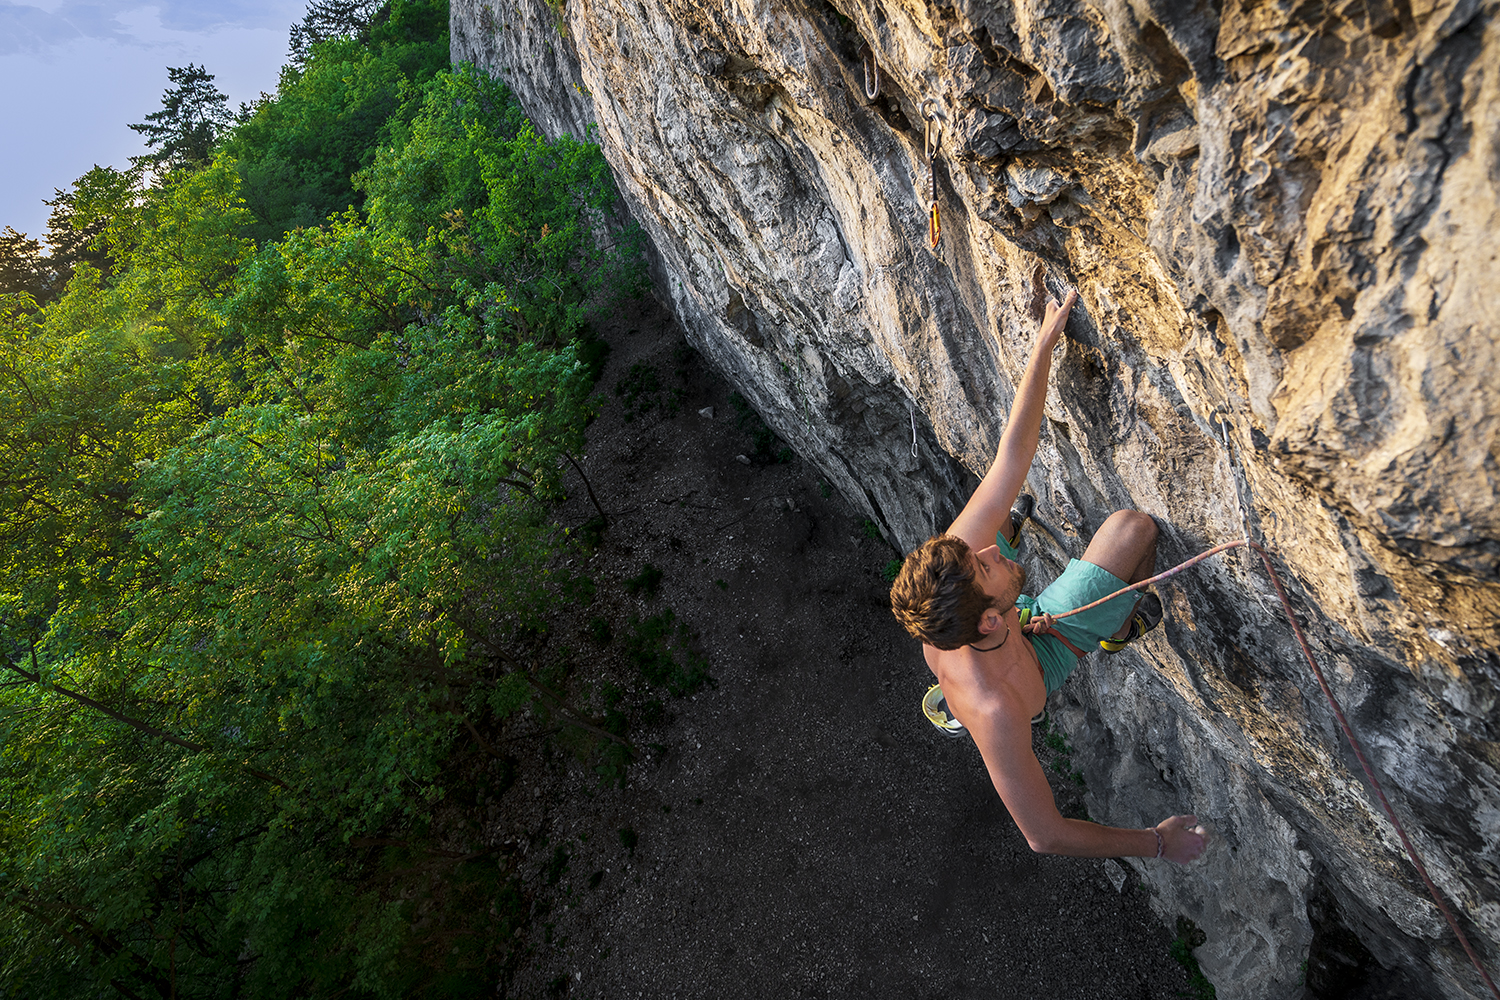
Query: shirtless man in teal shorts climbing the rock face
xmin=891 ymin=291 xmax=1208 ymax=864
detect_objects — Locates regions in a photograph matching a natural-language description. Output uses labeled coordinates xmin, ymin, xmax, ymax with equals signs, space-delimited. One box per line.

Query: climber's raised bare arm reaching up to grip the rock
xmin=948 ymin=291 xmax=1079 ymax=549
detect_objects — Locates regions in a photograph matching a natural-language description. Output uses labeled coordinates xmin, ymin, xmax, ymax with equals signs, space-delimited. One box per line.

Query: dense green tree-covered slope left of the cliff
xmin=0 ymin=0 xmax=645 ymax=997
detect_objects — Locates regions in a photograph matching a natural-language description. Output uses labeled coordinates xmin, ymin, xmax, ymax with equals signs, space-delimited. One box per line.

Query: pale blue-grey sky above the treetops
xmin=0 ymin=0 xmax=308 ymax=238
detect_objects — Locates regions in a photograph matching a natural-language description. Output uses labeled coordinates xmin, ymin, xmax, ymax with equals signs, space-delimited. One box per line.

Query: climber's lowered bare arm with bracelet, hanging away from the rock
xmin=966 ymin=705 xmax=1208 ymax=864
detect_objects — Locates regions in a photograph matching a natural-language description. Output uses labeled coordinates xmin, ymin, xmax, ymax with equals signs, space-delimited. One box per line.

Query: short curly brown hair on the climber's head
xmin=891 ymin=535 xmax=998 ymax=649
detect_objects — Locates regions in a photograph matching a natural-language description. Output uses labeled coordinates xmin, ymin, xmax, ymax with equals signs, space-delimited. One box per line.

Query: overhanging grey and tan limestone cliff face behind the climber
xmin=453 ymin=0 xmax=1500 ymax=1000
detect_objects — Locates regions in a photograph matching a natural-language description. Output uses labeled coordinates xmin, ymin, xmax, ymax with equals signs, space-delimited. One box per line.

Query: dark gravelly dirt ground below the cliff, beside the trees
xmin=506 ymin=301 xmax=1197 ymax=1000
